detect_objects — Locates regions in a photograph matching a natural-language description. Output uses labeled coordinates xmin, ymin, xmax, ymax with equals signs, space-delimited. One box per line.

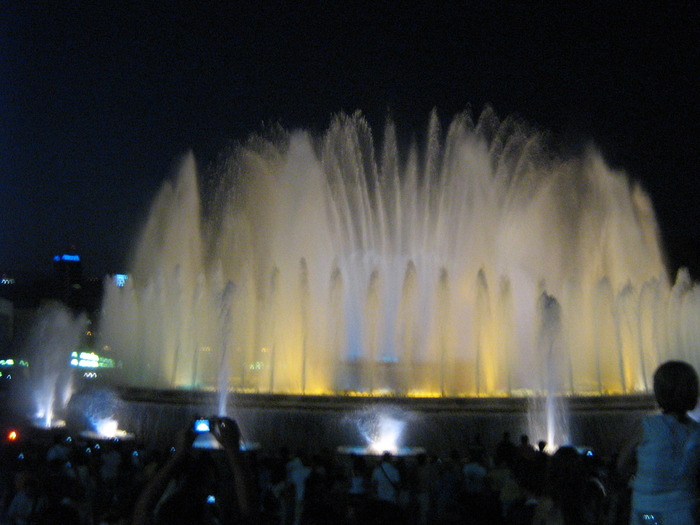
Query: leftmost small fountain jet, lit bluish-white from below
xmin=26 ymin=303 xmax=88 ymax=428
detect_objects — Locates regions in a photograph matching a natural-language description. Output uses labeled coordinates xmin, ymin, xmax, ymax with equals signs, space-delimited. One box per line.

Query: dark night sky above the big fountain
xmin=0 ymin=0 xmax=700 ymax=275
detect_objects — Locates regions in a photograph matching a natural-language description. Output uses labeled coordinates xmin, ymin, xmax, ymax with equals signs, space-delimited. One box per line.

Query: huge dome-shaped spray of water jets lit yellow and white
xmin=100 ymin=109 xmax=700 ymax=396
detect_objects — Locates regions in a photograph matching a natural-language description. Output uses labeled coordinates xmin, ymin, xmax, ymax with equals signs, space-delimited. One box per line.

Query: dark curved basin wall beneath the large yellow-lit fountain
xmin=94 ymin=388 xmax=656 ymax=456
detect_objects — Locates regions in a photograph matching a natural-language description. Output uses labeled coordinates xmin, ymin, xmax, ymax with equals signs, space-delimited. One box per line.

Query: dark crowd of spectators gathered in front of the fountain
xmin=0 ymin=420 xmax=630 ymax=525
